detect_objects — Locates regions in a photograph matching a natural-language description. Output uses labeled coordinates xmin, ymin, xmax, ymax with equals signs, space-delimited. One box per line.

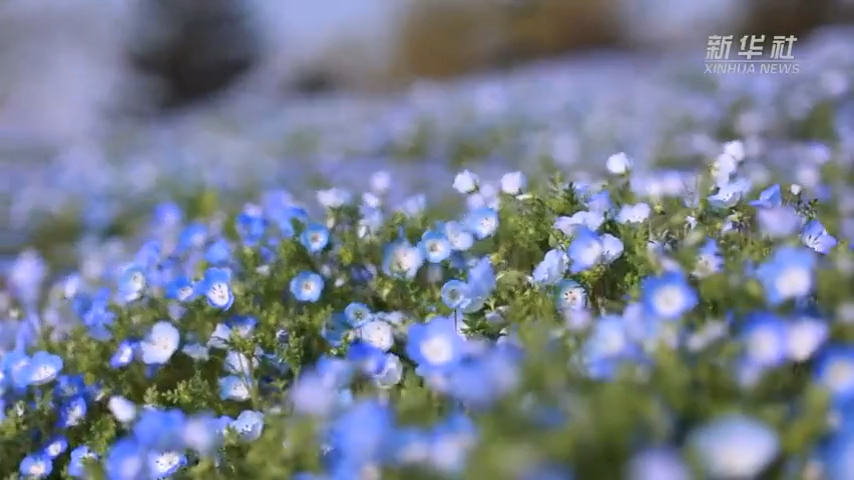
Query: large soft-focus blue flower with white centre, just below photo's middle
xmin=406 ymin=317 xmax=466 ymax=369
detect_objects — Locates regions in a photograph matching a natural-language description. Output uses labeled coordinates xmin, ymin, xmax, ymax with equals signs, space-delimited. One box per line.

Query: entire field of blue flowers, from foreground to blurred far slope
xmin=5 ymin=29 xmax=854 ymax=480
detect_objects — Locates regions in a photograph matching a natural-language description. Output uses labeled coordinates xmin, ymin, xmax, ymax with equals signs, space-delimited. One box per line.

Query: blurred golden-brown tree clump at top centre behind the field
xmin=392 ymin=0 xmax=618 ymax=78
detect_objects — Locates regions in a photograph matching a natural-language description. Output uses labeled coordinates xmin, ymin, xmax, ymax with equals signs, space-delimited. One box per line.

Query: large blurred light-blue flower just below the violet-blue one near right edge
xmin=756 ymin=247 xmax=815 ymax=307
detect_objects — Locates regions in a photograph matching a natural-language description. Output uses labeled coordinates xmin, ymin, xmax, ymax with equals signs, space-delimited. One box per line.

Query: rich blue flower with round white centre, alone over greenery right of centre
xmin=641 ymin=272 xmax=699 ymax=320
